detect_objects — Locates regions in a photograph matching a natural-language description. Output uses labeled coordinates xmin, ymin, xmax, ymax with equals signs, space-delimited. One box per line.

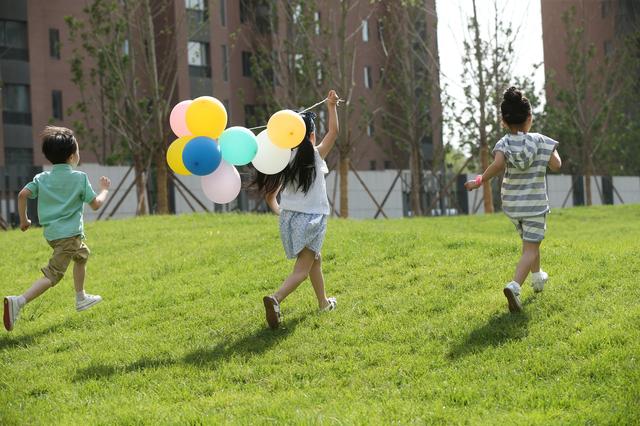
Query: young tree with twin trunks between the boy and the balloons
xmin=66 ymin=0 xmax=181 ymax=214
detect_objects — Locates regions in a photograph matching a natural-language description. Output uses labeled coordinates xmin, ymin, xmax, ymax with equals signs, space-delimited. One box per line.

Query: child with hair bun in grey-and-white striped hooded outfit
xmin=465 ymin=87 xmax=562 ymax=312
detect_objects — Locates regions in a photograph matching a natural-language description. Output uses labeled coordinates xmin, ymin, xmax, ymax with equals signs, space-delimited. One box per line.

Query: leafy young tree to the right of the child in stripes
xmin=546 ymin=7 xmax=639 ymax=205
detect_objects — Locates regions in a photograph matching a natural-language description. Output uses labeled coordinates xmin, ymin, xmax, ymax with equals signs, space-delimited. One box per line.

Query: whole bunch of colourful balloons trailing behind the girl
xmin=167 ymin=96 xmax=306 ymax=204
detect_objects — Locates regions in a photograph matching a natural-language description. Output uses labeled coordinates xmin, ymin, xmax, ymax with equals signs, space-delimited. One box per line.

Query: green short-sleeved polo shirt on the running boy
xmin=25 ymin=164 xmax=96 ymax=241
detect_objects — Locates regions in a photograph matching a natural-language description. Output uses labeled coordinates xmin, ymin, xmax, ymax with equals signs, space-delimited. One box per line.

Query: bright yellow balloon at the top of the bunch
xmin=186 ymin=96 xmax=227 ymax=139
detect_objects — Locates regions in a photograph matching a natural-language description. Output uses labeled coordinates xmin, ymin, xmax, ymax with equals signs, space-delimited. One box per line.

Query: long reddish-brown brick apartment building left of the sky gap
xmin=0 ymin=0 xmax=441 ymax=223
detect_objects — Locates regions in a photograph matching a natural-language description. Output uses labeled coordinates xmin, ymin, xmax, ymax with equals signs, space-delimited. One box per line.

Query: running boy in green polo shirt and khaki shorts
xmin=4 ymin=126 xmax=111 ymax=331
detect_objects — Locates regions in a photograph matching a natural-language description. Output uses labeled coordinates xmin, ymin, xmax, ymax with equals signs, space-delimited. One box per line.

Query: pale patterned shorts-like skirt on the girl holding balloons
xmin=280 ymin=210 xmax=328 ymax=259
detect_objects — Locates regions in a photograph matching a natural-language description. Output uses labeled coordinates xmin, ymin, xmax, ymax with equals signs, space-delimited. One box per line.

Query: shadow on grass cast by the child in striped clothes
xmin=449 ymin=297 xmax=535 ymax=359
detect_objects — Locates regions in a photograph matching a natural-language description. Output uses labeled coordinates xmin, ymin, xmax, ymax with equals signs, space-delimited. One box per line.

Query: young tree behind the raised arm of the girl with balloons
xmin=241 ymin=0 xmax=379 ymax=217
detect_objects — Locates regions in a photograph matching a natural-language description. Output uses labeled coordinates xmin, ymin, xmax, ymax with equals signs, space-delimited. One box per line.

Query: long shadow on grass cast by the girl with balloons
xmin=73 ymin=317 xmax=305 ymax=382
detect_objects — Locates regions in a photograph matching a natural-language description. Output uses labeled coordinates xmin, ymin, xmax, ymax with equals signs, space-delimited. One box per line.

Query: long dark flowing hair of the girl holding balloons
xmin=252 ymin=112 xmax=316 ymax=194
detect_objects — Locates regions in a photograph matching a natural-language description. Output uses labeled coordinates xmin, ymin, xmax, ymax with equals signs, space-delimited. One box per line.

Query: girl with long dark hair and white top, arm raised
xmin=255 ymin=90 xmax=339 ymax=328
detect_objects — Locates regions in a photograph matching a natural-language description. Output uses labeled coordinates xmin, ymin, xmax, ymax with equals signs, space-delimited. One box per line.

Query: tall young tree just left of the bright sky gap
xmin=380 ymin=1 xmax=443 ymax=216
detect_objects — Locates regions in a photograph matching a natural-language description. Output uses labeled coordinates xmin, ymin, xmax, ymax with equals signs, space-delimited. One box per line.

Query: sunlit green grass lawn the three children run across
xmin=0 ymin=206 xmax=640 ymax=425
